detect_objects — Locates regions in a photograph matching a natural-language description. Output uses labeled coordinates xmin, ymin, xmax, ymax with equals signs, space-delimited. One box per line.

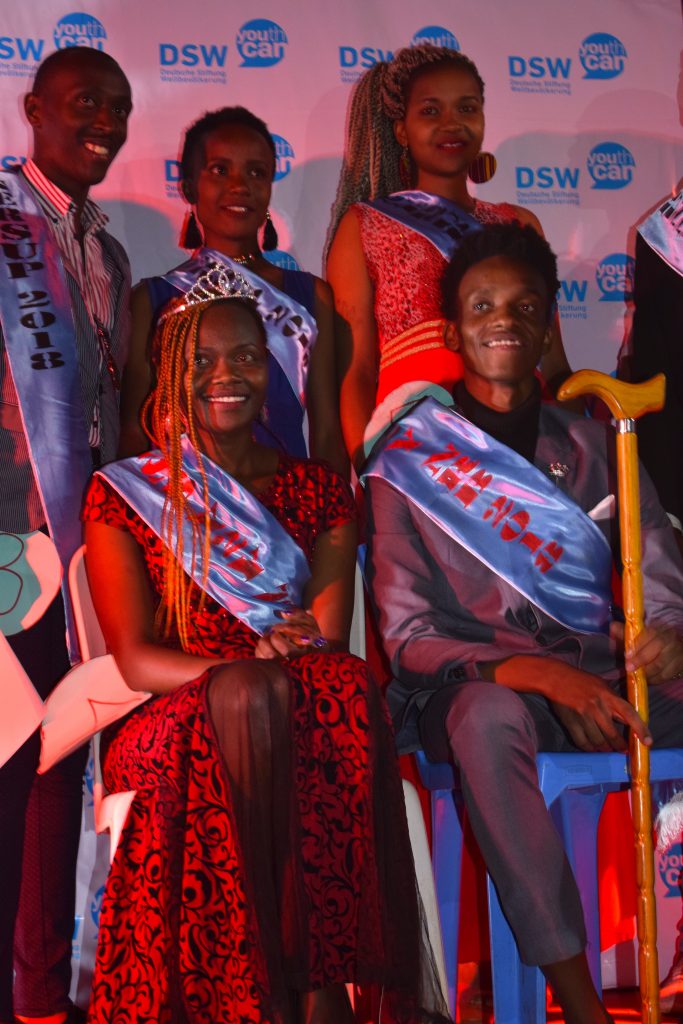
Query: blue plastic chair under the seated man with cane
xmin=417 ymin=750 xmax=683 ymax=1024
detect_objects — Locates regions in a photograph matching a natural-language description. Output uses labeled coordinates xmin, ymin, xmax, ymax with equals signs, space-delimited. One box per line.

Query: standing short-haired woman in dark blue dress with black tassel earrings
xmin=121 ymin=106 xmax=348 ymax=474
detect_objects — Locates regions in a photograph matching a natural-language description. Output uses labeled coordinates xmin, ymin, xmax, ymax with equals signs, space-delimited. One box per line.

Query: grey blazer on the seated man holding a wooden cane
xmin=367 ymin=403 xmax=683 ymax=743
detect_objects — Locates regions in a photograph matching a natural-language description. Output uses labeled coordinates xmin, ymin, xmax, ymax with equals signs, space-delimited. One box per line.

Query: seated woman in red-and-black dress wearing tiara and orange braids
xmin=84 ymin=275 xmax=444 ymax=1024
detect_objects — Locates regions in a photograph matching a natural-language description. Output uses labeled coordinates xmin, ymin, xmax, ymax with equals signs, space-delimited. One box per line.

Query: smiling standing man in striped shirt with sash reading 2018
xmin=0 ymin=47 xmax=131 ymax=1024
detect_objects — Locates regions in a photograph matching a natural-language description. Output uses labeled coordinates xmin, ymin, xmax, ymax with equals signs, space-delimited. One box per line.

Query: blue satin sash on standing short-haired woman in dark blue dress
xmin=164 ymin=249 xmax=317 ymax=409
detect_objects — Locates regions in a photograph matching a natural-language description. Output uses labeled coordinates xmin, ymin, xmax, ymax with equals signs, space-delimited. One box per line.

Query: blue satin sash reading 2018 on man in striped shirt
xmin=0 ymin=174 xmax=92 ymax=660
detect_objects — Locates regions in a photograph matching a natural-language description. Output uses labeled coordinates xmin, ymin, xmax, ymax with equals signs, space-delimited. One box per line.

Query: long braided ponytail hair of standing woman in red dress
xmin=326 ymin=43 xmax=484 ymax=251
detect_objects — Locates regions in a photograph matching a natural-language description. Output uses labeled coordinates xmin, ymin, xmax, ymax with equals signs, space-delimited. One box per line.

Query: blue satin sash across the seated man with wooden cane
xmin=361 ymin=398 xmax=611 ymax=633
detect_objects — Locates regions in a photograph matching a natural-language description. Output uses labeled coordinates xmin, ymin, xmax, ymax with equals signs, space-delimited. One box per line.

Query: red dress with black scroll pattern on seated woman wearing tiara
xmin=83 ymin=456 xmax=441 ymax=1024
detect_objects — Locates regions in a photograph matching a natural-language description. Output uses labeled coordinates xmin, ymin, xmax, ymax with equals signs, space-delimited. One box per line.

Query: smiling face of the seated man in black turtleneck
xmin=446 ymin=256 xmax=551 ymax=409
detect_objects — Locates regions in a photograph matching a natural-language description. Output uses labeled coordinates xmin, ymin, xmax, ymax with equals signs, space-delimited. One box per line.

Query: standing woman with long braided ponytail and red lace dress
xmin=327 ymin=45 xmax=569 ymax=467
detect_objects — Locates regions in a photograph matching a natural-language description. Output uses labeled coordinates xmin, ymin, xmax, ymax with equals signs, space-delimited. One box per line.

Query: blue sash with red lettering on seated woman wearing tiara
xmin=97 ymin=437 xmax=310 ymax=634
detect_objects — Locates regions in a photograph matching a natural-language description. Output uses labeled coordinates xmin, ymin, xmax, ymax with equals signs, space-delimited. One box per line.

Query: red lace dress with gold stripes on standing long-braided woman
xmin=352 ymin=200 xmax=517 ymax=406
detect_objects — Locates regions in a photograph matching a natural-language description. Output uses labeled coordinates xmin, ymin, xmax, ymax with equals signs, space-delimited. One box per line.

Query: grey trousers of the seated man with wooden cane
xmin=420 ymin=679 xmax=683 ymax=966
